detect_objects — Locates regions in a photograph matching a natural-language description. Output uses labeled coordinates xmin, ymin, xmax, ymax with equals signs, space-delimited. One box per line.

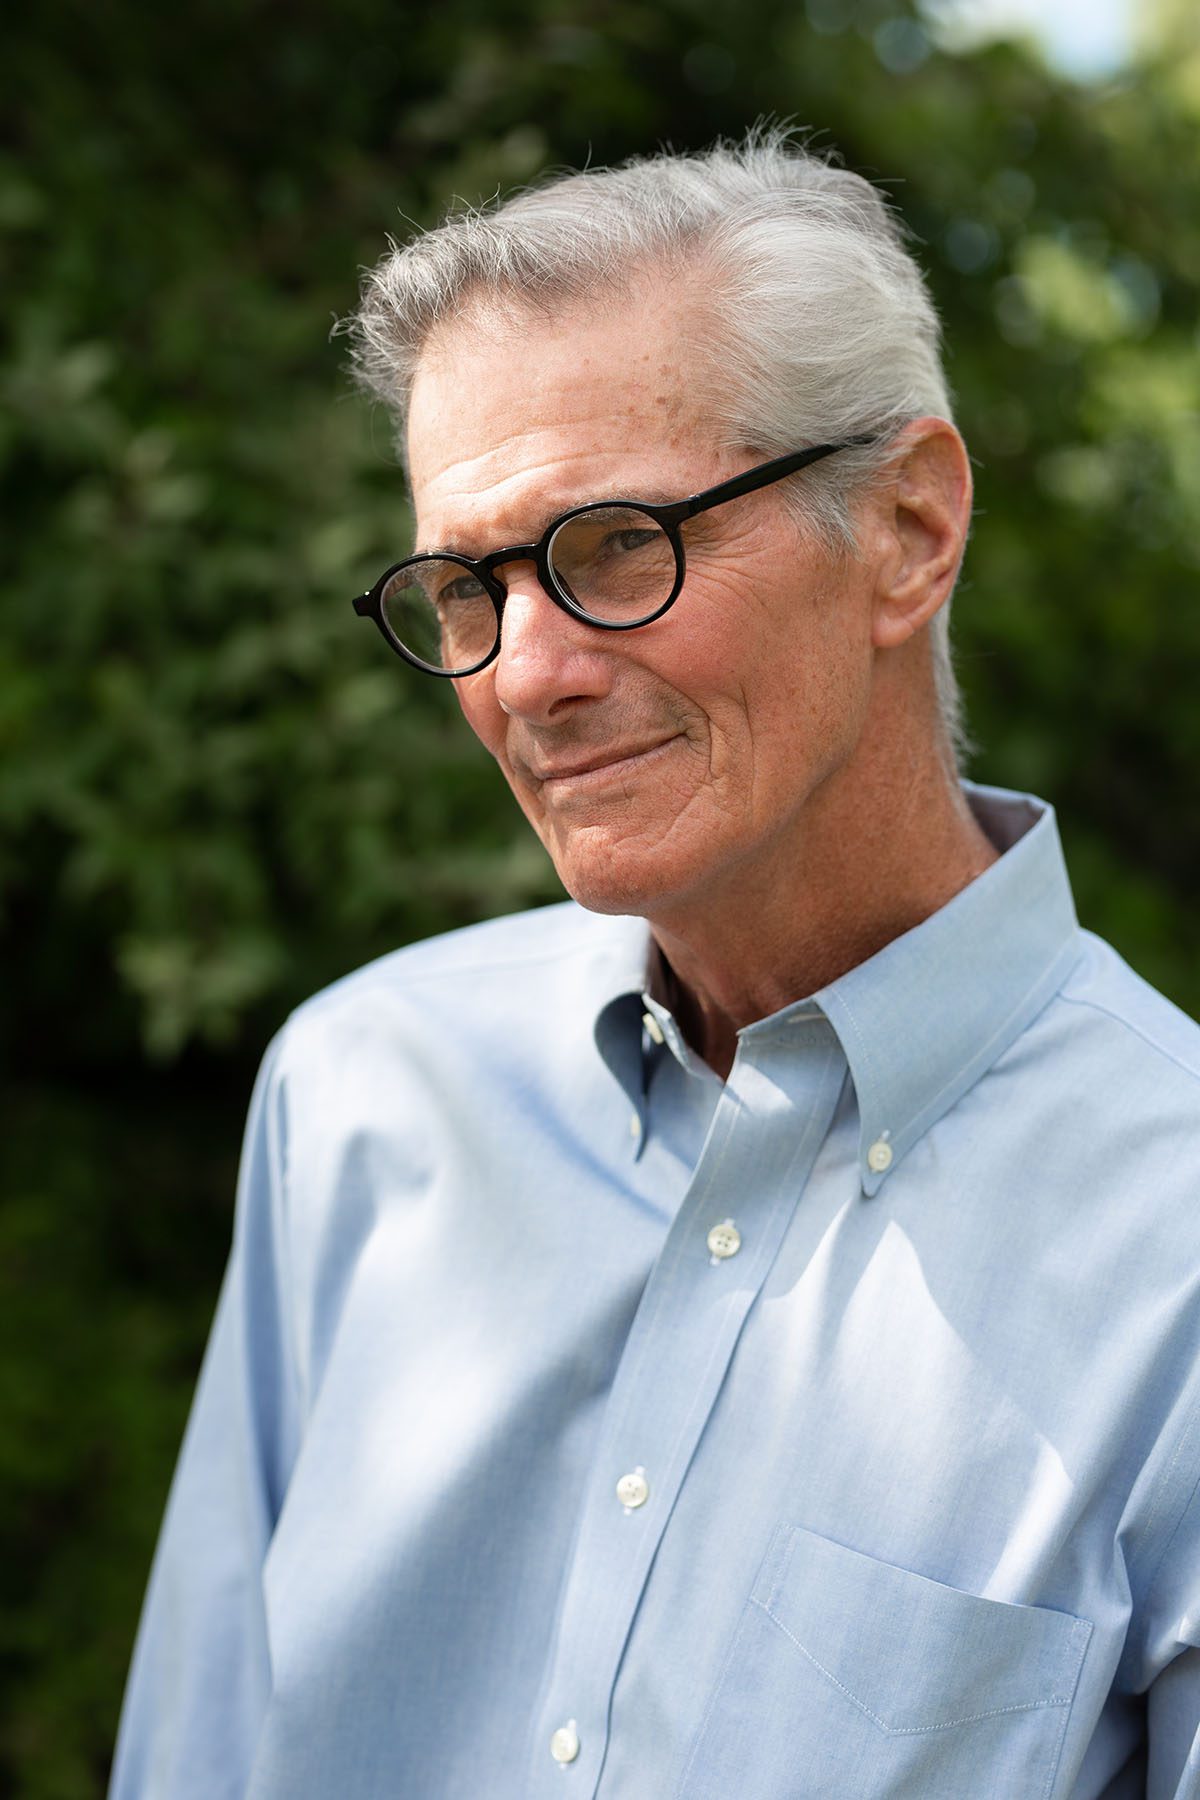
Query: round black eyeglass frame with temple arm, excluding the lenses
xmin=353 ymin=436 xmax=876 ymax=680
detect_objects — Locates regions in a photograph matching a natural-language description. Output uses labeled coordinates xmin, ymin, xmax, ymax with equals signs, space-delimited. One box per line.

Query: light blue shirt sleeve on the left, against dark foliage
xmin=110 ymin=1040 xmax=297 ymax=1800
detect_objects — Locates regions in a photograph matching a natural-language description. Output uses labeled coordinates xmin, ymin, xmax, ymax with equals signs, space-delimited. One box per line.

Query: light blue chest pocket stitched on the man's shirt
xmin=678 ymin=1525 xmax=1092 ymax=1800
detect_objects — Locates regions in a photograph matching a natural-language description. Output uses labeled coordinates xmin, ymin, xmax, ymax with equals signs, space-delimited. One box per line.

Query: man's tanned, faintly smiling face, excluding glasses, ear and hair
xmin=408 ymin=293 xmax=871 ymax=918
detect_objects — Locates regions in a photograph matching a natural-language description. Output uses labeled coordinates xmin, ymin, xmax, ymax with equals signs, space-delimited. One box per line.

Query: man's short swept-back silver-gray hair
xmin=344 ymin=126 xmax=966 ymax=758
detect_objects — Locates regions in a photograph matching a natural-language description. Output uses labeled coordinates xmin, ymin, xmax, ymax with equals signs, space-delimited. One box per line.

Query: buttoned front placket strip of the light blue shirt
xmin=524 ymin=1010 xmax=846 ymax=1800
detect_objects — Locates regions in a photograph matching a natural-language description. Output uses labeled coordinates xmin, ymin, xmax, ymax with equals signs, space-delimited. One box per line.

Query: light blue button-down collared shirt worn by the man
xmin=113 ymin=788 xmax=1200 ymax=1800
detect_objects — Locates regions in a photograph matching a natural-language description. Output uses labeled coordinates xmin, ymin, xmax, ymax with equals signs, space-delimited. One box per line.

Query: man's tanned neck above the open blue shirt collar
xmin=649 ymin=738 xmax=997 ymax=1076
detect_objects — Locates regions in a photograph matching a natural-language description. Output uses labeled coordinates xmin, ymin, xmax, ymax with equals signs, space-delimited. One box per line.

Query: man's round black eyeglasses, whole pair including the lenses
xmin=354 ymin=437 xmax=874 ymax=677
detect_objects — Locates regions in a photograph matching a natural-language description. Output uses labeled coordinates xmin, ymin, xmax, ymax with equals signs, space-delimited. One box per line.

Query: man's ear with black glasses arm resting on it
xmin=871 ymin=418 xmax=972 ymax=650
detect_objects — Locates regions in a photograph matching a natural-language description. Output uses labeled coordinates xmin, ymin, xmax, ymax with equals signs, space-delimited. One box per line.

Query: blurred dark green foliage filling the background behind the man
xmin=0 ymin=0 xmax=1200 ymax=1800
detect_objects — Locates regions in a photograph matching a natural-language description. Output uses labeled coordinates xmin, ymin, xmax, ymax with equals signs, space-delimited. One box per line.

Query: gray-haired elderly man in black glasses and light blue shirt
xmin=113 ymin=137 xmax=1200 ymax=1800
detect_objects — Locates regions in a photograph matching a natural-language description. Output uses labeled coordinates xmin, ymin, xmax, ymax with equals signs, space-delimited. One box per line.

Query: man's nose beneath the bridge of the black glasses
xmin=493 ymin=562 xmax=612 ymax=724
